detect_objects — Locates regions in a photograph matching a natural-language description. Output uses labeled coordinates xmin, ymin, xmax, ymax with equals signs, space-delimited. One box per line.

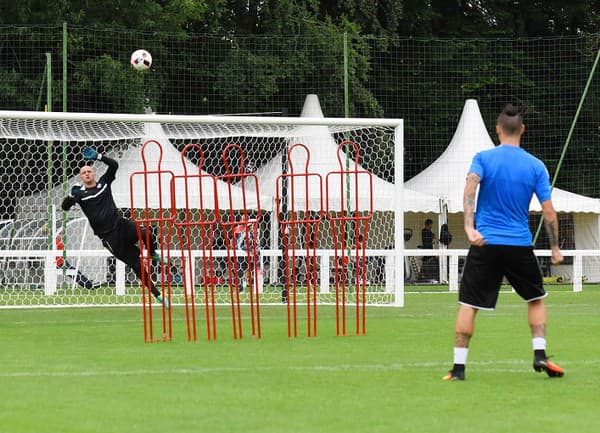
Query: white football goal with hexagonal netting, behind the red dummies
xmin=0 ymin=104 xmax=405 ymax=307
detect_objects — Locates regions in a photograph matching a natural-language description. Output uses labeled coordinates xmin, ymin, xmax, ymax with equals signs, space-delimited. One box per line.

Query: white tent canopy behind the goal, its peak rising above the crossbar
xmin=241 ymin=95 xmax=439 ymax=212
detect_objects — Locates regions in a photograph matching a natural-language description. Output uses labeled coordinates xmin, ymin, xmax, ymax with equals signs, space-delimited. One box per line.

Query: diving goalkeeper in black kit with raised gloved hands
xmin=62 ymin=147 xmax=169 ymax=308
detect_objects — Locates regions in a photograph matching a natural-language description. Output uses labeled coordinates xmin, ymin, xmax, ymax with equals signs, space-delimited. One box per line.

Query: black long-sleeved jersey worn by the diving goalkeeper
xmin=63 ymin=155 xmax=122 ymax=238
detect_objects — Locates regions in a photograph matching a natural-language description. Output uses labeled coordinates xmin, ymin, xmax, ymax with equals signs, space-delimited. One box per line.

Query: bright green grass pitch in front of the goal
xmin=0 ymin=287 xmax=600 ymax=433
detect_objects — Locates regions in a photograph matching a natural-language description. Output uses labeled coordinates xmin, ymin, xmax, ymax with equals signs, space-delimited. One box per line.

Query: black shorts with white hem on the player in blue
xmin=458 ymin=245 xmax=547 ymax=310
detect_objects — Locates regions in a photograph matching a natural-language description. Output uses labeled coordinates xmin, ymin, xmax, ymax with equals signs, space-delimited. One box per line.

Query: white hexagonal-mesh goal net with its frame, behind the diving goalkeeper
xmin=0 ymin=95 xmax=404 ymax=306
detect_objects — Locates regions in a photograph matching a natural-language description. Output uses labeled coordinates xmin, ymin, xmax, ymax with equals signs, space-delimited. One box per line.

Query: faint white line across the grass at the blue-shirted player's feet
xmin=0 ymin=359 xmax=600 ymax=378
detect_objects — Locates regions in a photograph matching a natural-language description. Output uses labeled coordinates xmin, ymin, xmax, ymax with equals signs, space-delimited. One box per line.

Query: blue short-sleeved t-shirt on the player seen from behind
xmin=469 ymin=144 xmax=551 ymax=246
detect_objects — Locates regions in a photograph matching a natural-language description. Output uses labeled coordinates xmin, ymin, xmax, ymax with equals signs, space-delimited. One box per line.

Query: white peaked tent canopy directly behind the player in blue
xmin=405 ymin=99 xmax=600 ymax=214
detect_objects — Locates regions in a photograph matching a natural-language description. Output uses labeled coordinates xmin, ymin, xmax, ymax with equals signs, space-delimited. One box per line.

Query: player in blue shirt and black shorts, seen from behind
xmin=444 ymin=104 xmax=564 ymax=380
